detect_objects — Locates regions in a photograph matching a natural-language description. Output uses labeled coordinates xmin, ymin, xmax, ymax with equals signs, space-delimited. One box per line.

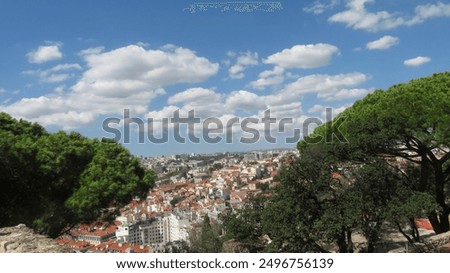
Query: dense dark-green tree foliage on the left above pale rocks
xmin=0 ymin=113 xmax=154 ymax=236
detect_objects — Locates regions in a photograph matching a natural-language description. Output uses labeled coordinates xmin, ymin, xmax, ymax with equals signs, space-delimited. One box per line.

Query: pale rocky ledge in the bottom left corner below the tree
xmin=0 ymin=224 xmax=71 ymax=253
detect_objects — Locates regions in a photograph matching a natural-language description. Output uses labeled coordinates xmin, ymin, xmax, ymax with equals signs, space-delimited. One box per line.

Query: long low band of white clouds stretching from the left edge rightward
xmin=1 ymin=69 xmax=371 ymax=130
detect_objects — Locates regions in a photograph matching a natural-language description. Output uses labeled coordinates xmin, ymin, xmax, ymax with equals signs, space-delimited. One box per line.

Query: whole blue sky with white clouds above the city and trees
xmin=0 ymin=0 xmax=450 ymax=155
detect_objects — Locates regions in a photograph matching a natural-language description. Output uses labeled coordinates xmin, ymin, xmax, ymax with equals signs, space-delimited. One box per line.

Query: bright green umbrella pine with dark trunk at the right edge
xmin=298 ymin=72 xmax=450 ymax=233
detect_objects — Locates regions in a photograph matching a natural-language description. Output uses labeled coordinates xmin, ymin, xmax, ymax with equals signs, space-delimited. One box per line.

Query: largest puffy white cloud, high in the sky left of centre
xmin=73 ymin=45 xmax=219 ymax=98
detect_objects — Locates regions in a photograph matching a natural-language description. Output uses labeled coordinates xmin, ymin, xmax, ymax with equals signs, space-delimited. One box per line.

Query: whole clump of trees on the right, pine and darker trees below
xmin=228 ymin=73 xmax=450 ymax=252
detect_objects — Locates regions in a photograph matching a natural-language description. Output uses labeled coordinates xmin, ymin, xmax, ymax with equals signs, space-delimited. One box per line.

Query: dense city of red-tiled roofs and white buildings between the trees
xmin=56 ymin=149 xmax=298 ymax=253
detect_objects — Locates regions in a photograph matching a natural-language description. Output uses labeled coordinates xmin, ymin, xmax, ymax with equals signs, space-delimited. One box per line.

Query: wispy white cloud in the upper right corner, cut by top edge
xmin=328 ymin=0 xmax=450 ymax=32
